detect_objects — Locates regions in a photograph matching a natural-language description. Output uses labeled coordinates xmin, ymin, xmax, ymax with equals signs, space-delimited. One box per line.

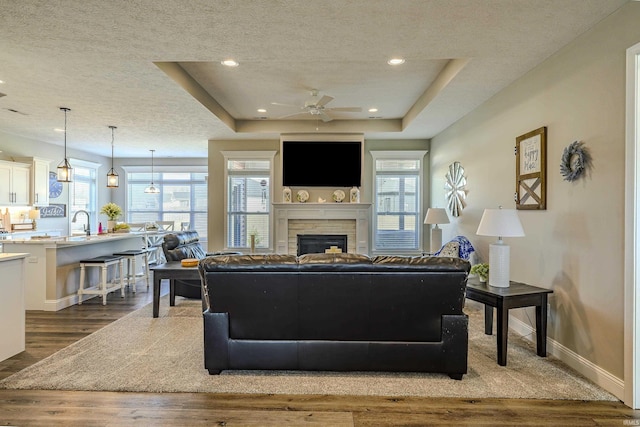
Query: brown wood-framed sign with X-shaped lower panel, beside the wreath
xmin=515 ymin=126 xmax=547 ymax=210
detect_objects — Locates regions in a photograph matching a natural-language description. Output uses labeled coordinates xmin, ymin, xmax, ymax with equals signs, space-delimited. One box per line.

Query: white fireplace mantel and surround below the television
xmin=273 ymin=203 xmax=371 ymax=254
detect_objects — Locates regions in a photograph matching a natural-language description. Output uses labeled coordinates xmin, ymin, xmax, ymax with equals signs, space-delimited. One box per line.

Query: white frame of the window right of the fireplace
xmin=370 ymin=150 xmax=428 ymax=255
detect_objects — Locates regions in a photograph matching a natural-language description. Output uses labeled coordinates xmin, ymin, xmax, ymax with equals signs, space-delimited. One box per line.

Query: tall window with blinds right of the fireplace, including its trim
xmin=371 ymin=151 xmax=426 ymax=252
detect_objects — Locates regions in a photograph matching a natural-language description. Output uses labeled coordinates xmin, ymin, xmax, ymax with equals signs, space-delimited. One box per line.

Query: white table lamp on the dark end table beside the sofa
xmin=476 ymin=208 xmax=524 ymax=288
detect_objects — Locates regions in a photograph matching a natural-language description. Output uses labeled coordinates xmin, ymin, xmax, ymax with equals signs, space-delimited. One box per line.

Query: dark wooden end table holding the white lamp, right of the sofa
xmin=467 ymin=279 xmax=553 ymax=366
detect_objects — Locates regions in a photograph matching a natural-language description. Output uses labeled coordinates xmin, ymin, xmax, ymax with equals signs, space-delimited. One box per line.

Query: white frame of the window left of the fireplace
xmin=221 ymin=150 xmax=277 ymax=252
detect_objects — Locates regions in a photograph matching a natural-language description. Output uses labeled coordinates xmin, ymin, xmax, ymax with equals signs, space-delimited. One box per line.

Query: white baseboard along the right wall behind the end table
xmin=507 ymin=316 xmax=624 ymax=400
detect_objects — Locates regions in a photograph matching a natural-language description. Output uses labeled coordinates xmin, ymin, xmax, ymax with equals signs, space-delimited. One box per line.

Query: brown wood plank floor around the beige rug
xmin=0 ymin=285 xmax=640 ymax=426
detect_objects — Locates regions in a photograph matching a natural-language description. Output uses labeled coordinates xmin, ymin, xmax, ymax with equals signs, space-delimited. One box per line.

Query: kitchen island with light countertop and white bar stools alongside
xmin=3 ymin=233 xmax=143 ymax=311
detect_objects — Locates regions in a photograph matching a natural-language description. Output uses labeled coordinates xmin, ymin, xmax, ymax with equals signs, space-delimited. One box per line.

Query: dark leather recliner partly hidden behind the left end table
xmin=162 ymin=230 xmax=240 ymax=299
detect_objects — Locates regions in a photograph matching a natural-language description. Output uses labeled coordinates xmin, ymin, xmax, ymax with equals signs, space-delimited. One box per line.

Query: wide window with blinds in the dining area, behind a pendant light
xmin=125 ymin=166 xmax=208 ymax=242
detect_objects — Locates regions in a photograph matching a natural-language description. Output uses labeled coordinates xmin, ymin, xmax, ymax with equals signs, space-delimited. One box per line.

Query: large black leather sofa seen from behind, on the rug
xmin=199 ymin=254 xmax=470 ymax=379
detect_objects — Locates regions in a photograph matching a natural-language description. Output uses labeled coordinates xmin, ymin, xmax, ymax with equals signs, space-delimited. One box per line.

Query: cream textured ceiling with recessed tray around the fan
xmin=0 ymin=0 xmax=627 ymax=157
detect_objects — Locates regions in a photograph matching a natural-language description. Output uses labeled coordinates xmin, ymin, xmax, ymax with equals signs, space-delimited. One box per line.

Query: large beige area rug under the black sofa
xmin=0 ymin=297 xmax=618 ymax=401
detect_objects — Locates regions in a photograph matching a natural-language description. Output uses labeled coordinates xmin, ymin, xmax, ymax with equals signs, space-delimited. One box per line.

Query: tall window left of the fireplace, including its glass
xmin=222 ymin=151 xmax=275 ymax=250
